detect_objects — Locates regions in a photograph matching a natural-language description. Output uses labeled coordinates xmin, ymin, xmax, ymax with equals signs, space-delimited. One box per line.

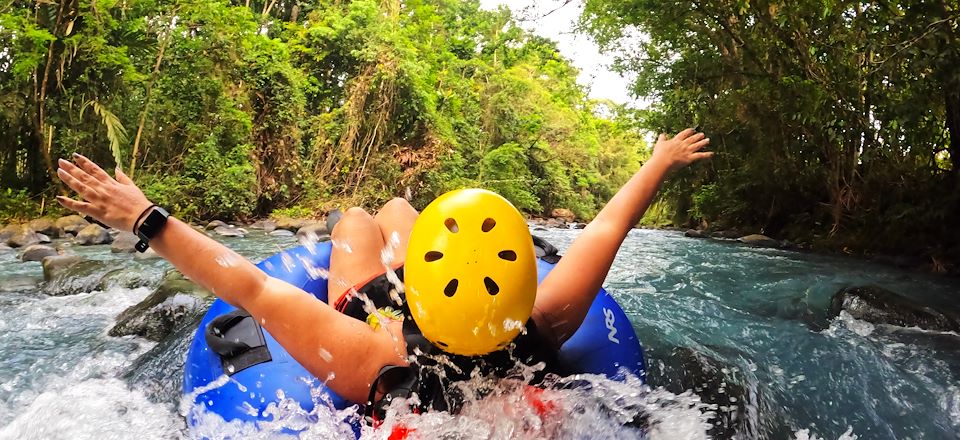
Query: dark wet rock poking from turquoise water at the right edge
xmin=830 ymin=286 xmax=960 ymax=332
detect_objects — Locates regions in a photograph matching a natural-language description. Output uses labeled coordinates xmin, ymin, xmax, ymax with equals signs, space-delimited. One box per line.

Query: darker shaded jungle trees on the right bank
xmin=581 ymin=0 xmax=960 ymax=268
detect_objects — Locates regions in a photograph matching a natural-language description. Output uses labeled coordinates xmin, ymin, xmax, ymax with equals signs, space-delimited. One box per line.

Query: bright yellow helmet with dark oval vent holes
xmin=404 ymin=189 xmax=537 ymax=356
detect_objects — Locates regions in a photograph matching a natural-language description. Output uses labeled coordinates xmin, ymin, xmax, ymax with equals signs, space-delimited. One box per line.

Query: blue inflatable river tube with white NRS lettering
xmin=183 ymin=242 xmax=646 ymax=435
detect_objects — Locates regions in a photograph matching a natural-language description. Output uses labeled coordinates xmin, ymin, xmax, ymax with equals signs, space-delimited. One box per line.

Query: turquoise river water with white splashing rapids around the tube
xmin=0 ymin=230 xmax=960 ymax=440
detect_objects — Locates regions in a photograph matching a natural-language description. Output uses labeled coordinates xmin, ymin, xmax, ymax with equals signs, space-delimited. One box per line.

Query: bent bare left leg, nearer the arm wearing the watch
xmin=327 ymin=207 xmax=383 ymax=305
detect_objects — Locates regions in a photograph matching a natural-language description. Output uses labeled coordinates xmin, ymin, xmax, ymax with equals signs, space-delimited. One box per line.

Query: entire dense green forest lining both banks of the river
xmin=0 ymin=0 xmax=960 ymax=270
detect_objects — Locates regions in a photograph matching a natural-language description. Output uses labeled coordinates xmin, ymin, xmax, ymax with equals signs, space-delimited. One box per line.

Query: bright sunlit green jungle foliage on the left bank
xmin=0 ymin=0 xmax=646 ymax=219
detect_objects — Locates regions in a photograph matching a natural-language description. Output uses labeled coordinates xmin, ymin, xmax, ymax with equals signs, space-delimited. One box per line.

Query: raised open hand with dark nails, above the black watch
xmin=57 ymin=154 xmax=150 ymax=231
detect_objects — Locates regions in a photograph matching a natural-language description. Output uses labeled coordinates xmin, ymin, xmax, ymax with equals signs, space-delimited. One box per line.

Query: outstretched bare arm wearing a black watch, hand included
xmin=57 ymin=155 xmax=404 ymax=403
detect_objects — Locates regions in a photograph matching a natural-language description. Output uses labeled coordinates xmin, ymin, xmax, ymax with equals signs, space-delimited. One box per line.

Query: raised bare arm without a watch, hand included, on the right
xmin=533 ymin=129 xmax=713 ymax=347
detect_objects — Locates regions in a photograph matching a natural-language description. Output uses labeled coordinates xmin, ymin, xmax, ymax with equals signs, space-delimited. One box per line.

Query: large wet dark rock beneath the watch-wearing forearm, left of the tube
xmin=109 ymin=270 xmax=212 ymax=341
